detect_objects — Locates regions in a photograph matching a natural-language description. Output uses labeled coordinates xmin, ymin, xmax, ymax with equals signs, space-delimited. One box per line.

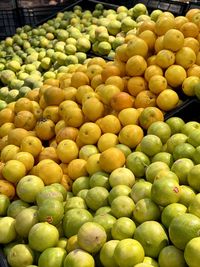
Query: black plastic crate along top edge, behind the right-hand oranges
xmin=133 ymin=0 xmax=188 ymax=16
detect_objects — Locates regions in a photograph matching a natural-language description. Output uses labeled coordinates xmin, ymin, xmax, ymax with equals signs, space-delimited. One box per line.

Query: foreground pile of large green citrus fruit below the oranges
xmin=0 ymin=117 xmax=200 ymax=267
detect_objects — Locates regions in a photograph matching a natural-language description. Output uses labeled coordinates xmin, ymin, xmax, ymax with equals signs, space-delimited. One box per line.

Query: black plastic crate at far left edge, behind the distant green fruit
xmin=0 ymin=8 xmax=20 ymax=40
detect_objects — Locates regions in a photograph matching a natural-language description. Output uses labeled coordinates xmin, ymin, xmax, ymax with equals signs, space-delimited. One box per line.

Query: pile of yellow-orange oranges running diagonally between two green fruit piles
xmin=0 ymin=9 xmax=200 ymax=199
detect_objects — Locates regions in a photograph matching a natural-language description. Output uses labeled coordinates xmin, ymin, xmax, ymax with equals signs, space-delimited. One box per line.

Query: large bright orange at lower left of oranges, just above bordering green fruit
xmin=37 ymin=160 xmax=63 ymax=185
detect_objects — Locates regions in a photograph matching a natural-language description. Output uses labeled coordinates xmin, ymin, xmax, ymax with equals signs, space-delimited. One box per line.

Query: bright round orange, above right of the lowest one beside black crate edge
xmin=165 ymin=65 xmax=187 ymax=87
